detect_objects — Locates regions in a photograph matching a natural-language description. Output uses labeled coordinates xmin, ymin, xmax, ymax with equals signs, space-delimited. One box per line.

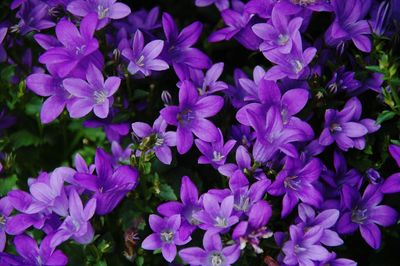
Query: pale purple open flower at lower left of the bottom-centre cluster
xmin=142 ymin=214 xmax=191 ymax=262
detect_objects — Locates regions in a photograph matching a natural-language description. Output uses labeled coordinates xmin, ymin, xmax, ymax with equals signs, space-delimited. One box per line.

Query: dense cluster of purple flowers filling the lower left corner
xmin=0 ymin=149 xmax=138 ymax=265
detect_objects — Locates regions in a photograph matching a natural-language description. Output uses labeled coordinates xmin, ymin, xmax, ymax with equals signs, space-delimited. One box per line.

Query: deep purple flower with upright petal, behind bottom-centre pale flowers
xmin=157 ymin=176 xmax=202 ymax=235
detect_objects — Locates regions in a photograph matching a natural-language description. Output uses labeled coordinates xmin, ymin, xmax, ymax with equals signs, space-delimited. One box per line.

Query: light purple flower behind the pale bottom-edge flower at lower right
xmin=298 ymin=203 xmax=343 ymax=247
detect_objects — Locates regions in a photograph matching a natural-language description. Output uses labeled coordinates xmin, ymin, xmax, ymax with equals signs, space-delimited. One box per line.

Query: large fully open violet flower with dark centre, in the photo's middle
xmin=160 ymin=81 xmax=224 ymax=154
